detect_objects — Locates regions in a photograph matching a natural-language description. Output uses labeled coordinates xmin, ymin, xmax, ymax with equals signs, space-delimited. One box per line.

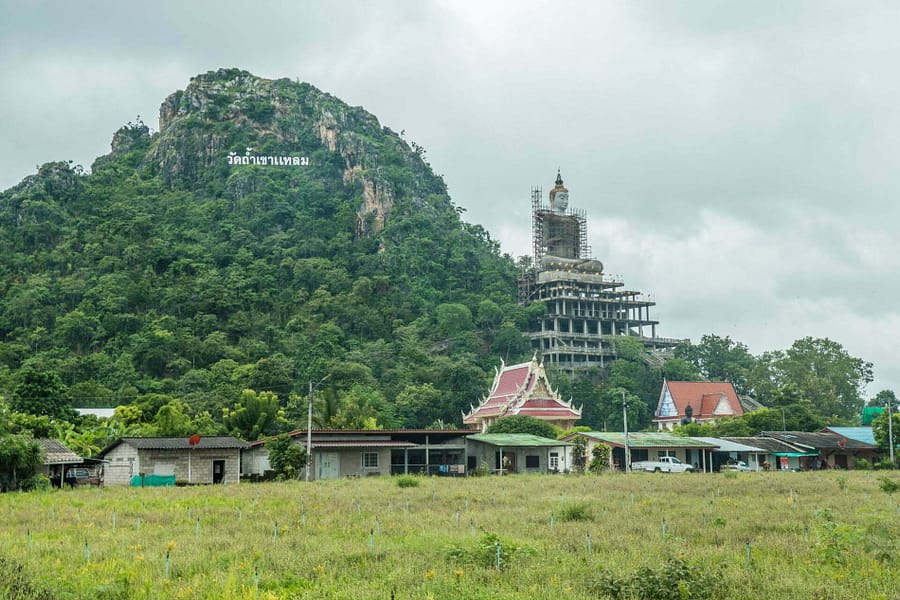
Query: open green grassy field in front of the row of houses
xmin=0 ymin=471 xmax=900 ymax=600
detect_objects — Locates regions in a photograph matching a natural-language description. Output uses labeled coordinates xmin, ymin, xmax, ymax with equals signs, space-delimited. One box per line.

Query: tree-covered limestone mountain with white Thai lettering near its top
xmin=0 ymin=69 xmax=529 ymax=426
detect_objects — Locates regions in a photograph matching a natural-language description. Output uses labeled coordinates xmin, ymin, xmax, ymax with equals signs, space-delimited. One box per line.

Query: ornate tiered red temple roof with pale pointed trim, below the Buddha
xmin=463 ymin=356 xmax=581 ymax=433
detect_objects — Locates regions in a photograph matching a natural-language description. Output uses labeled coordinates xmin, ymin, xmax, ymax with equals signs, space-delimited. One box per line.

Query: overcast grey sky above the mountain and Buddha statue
xmin=0 ymin=0 xmax=900 ymax=396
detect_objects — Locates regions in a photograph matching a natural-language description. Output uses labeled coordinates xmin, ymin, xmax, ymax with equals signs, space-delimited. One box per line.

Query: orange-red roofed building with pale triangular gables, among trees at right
xmin=653 ymin=381 xmax=744 ymax=431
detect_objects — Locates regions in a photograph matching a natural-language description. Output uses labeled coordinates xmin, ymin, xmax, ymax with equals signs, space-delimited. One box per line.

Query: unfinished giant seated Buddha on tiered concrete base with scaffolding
xmin=518 ymin=173 xmax=687 ymax=370
